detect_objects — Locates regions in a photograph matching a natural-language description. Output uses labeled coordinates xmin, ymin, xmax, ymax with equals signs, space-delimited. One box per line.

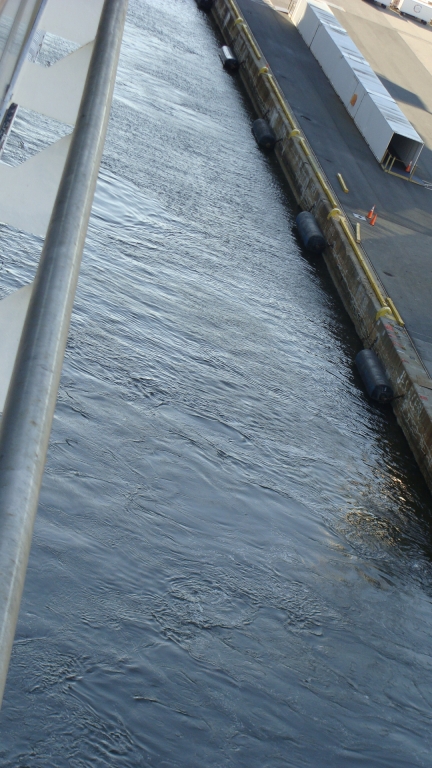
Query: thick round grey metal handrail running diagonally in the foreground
xmin=0 ymin=0 xmax=127 ymax=701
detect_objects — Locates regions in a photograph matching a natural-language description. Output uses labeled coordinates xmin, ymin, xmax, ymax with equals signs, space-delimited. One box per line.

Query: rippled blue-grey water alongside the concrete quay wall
xmin=0 ymin=0 xmax=432 ymax=768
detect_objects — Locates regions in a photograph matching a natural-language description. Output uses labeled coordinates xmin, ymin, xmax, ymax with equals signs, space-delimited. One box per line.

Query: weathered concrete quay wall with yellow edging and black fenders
xmin=212 ymin=0 xmax=432 ymax=490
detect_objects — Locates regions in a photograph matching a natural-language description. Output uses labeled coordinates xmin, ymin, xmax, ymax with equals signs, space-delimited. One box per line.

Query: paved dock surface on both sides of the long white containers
xmin=237 ymin=0 xmax=432 ymax=375
